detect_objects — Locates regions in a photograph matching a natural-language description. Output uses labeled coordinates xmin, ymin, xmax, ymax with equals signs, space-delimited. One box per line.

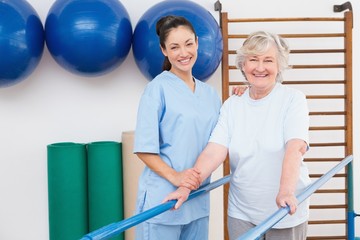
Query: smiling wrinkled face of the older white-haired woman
xmin=242 ymin=46 xmax=279 ymax=89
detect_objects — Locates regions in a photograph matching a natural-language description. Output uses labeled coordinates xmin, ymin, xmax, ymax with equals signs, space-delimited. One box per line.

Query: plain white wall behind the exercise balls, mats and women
xmin=0 ymin=0 xmax=360 ymax=240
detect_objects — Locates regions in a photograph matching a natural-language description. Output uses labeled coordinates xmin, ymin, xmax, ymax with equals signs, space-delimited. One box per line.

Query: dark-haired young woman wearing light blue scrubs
xmin=134 ymin=16 xmax=221 ymax=240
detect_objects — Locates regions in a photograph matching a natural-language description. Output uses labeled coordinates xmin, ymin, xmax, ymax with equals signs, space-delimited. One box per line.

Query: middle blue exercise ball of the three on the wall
xmin=45 ymin=0 xmax=132 ymax=76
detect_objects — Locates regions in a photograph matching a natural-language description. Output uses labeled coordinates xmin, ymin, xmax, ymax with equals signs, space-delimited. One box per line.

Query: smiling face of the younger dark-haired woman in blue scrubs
xmin=161 ymin=26 xmax=198 ymax=74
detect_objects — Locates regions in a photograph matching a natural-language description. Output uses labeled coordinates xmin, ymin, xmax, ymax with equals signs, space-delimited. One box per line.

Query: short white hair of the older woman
xmin=235 ymin=31 xmax=290 ymax=82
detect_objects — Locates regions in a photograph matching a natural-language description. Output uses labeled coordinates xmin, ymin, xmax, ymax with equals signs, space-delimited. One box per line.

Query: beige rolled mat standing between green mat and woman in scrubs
xmin=121 ymin=131 xmax=145 ymax=240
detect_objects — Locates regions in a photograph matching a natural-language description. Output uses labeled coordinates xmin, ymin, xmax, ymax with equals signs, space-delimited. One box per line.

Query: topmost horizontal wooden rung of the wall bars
xmin=227 ymin=17 xmax=345 ymax=23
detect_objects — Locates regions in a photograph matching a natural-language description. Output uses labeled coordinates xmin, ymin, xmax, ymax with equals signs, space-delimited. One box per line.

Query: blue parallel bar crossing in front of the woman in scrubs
xmin=81 ymin=175 xmax=231 ymax=240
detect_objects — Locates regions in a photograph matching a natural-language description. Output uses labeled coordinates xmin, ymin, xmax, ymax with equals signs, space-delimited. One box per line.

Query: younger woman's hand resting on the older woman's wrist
xmin=171 ymin=168 xmax=201 ymax=190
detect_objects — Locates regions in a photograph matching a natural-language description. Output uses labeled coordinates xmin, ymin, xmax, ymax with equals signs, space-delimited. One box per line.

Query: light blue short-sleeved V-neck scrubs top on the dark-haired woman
xmin=134 ymin=71 xmax=221 ymax=225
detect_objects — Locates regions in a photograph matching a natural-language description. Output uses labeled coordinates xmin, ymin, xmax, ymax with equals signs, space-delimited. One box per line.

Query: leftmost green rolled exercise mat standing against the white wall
xmin=47 ymin=142 xmax=88 ymax=240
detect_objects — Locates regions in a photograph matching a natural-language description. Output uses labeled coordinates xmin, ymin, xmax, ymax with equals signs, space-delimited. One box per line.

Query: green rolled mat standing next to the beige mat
xmin=87 ymin=141 xmax=124 ymax=239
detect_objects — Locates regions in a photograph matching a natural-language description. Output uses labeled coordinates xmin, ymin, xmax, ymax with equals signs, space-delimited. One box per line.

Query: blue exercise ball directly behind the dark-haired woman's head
xmin=133 ymin=0 xmax=223 ymax=81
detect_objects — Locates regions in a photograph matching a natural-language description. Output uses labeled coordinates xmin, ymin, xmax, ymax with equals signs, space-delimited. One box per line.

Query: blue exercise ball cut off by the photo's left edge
xmin=0 ymin=0 xmax=44 ymax=87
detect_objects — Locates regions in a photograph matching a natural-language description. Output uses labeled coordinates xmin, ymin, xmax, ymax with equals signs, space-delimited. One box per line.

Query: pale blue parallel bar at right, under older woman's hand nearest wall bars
xmin=237 ymin=155 xmax=353 ymax=240
